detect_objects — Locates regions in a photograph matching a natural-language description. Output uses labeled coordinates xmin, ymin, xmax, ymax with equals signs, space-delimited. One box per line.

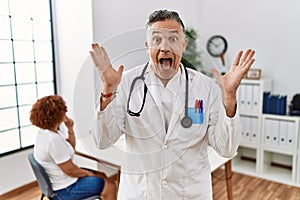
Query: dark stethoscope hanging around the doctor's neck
xmin=127 ymin=62 xmax=193 ymax=128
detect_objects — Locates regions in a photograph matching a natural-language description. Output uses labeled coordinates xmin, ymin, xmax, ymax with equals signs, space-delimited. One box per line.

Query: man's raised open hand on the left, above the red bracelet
xmin=90 ymin=43 xmax=124 ymax=93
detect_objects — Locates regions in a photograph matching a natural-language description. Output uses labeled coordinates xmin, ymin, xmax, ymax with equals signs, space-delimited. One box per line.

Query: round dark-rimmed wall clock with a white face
xmin=207 ymin=35 xmax=227 ymax=57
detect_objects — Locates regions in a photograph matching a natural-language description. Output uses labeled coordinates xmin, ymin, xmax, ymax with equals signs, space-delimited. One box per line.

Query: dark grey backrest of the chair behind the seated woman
xmin=28 ymin=153 xmax=55 ymax=198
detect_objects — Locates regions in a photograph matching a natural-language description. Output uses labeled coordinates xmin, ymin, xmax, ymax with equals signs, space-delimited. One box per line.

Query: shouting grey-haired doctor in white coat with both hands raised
xmin=90 ymin=10 xmax=255 ymax=200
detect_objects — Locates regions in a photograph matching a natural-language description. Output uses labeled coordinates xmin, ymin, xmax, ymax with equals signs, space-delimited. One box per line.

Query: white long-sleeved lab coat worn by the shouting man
xmin=97 ymin=65 xmax=241 ymax=200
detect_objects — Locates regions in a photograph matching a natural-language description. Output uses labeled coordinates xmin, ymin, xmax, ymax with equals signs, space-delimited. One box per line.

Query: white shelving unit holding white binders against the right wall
xmin=232 ymin=79 xmax=300 ymax=187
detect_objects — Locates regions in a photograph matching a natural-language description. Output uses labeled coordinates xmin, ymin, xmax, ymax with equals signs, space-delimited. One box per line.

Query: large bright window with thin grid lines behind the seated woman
xmin=0 ymin=0 xmax=56 ymax=156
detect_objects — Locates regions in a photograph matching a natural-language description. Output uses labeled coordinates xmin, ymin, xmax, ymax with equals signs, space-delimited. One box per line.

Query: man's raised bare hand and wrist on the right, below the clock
xmin=212 ymin=49 xmax=255 ymax=117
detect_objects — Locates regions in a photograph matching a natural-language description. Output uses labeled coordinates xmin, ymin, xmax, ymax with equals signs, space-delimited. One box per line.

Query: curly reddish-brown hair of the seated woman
xmin=30 ymin=95 xmax=67 ymax=129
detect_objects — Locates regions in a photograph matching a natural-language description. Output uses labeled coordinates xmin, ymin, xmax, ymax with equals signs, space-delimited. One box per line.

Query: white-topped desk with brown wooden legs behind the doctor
xmin=76 ymin=137 xmax=233 ymax=200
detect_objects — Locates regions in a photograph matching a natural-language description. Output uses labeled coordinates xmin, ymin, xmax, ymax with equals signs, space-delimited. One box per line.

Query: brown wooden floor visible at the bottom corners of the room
xmin=0 ymin=169 xmax=300 ymax=200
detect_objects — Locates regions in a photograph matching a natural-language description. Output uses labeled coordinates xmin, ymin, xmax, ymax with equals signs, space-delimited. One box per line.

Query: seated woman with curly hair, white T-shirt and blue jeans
xmin=30 ymin=95 xmax=116 ymax=200
